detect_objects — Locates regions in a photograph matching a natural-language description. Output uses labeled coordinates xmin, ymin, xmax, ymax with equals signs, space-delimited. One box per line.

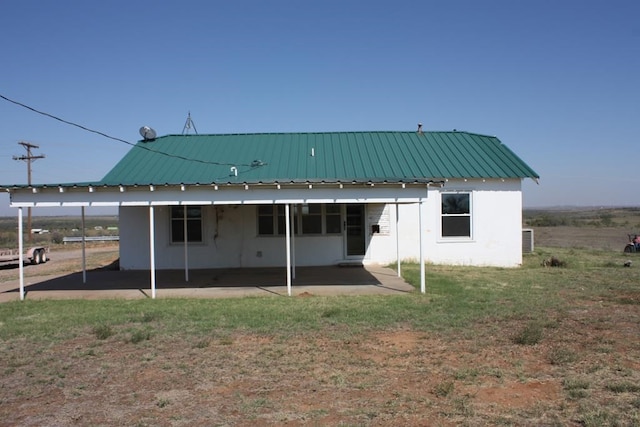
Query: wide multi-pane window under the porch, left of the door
xmin=257 ymin=203 xmax=342 ymax=236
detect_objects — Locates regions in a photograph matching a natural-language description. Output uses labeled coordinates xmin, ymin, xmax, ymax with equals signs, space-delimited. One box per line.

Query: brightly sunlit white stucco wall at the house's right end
xmin=369 ymin=180 xmax=522 ymax=267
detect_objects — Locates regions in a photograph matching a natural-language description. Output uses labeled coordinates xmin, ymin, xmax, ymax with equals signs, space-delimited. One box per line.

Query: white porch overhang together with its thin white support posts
xmin=8 ymin=180 xmax=436 ymax=299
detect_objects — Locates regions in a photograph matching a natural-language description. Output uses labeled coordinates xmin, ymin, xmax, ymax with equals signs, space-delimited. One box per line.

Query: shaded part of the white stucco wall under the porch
xmin=120 ymin=205 xmax=342 ymax=270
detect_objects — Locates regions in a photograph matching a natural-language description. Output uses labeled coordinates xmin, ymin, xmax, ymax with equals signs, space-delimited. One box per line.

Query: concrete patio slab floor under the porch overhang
xmin=0 ymin=265 xmax=415 ymax=302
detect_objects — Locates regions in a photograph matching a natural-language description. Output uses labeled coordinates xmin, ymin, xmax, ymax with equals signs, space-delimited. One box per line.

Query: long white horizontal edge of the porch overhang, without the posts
xmin=7 ymin=180 xmax=443 ymax=207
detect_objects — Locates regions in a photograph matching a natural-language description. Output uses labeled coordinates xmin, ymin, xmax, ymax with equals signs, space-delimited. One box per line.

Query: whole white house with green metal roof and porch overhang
xmin=4 ymin=129 xmax=538 ymax=300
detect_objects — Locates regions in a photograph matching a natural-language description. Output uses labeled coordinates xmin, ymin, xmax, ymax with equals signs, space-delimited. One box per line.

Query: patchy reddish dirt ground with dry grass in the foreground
xmin=0 ymin=233 xmax=640 ymax=426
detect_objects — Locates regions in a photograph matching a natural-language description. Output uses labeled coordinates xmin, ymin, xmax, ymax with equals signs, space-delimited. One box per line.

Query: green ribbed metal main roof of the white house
xmin=98 ymin=131 xmax=538 ymax=185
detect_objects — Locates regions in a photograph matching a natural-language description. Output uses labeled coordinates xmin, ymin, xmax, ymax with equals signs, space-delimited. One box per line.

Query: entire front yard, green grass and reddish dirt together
xmin=0 ymin=219 xmax=640 ymax=426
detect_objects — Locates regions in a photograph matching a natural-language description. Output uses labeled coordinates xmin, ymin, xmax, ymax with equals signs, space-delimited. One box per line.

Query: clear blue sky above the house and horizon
xmin=0 ymin=0 xmax=640 ymax=215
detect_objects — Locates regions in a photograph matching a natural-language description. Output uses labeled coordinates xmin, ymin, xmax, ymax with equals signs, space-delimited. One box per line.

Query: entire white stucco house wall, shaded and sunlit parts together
xmin=120 ymin=179 xmax=522 ymax=269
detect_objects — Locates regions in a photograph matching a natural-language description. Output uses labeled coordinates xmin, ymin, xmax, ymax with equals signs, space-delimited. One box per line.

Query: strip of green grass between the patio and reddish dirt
xmin=0 ymin=249 xmax=637 ymax=344
